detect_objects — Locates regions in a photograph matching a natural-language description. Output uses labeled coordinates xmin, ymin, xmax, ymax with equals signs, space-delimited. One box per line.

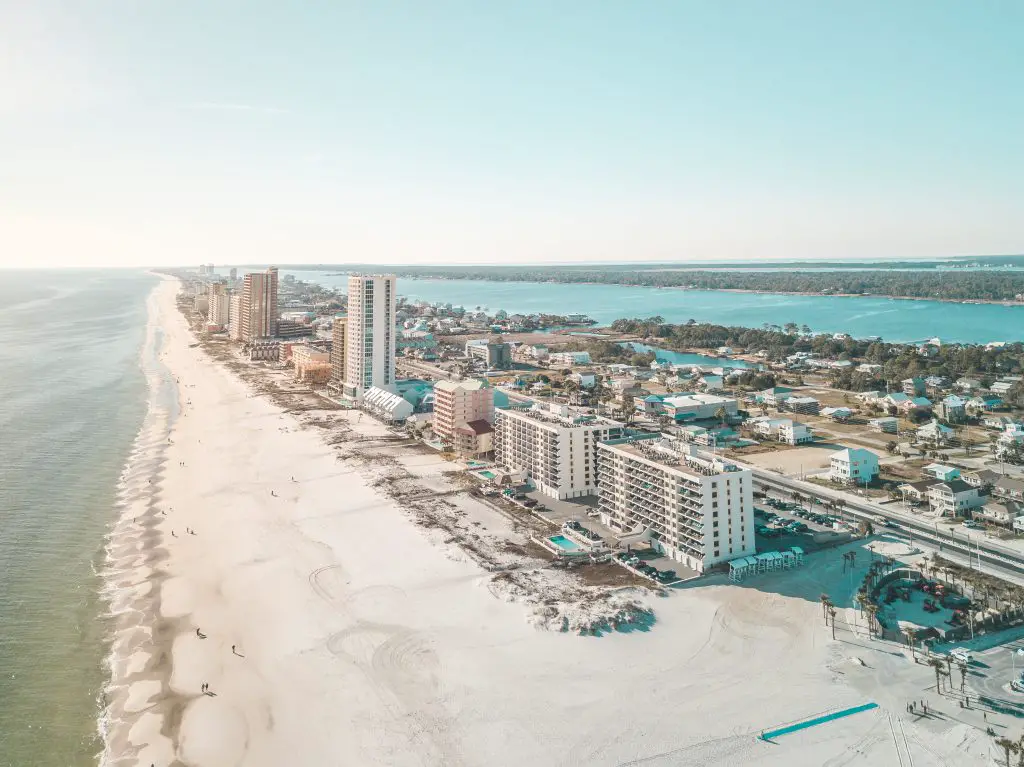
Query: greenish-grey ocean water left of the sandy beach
xmin=0 ymin=270 xmax=157 ymax=767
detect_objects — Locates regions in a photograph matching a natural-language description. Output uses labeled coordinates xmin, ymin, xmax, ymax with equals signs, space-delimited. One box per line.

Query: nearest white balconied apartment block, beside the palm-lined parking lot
xmin=598 ymin=438 xmax=755 ymax=571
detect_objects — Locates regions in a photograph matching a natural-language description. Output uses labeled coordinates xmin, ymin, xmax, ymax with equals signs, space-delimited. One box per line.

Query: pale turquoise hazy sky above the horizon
xmin=0 ymin=0 xmax=1024 ymax=266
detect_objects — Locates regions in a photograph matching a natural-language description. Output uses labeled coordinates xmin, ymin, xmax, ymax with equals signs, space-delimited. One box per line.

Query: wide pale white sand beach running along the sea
xmin=104 ymin=280 xmax=1003 ymax=767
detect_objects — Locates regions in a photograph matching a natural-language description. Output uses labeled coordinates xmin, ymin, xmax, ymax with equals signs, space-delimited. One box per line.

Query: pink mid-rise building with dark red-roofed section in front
xmin=433 ymin=379 xmax=495 ymax=457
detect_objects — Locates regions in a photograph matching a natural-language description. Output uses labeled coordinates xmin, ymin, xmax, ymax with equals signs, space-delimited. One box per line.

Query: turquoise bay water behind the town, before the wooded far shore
xmin=284 ymin=271 xmax=1024 ymax=343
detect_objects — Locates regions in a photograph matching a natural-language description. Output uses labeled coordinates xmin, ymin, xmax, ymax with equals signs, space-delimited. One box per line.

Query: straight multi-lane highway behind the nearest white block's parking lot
xmin=752 ymin=467 xmax=1024 ymax=585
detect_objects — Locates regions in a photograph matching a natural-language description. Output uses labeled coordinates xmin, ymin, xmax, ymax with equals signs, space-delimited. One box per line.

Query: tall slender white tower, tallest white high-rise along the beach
xmin=344 ymin=274 xmax=396 ymax=399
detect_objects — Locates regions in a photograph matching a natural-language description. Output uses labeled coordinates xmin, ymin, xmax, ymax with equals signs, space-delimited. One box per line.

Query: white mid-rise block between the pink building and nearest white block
xmin=494 ymin=406 xmax=625 ymax=499
